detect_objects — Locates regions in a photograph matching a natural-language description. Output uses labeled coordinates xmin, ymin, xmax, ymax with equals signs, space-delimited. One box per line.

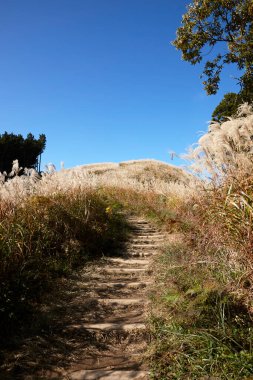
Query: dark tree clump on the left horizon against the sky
xmin=0 ymin=132 xmax=46 ymax=173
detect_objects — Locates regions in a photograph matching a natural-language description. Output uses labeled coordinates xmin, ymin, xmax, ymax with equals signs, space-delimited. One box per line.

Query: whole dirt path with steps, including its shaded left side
xmin=0 ymin=217 xmax=164 ymax=380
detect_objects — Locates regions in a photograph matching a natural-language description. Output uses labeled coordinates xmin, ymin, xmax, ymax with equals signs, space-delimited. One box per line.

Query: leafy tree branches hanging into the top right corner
xmin=173 ymin=0 xmax=253 ymax=96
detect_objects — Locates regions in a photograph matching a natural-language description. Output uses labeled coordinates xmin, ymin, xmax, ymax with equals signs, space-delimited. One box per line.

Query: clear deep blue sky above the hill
xmin=0 ymin=0 xmax=240 ymax=167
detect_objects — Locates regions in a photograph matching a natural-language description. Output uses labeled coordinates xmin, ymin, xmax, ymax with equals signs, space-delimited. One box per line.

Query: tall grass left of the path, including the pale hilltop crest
xmin=0 ymin=157 xmax=189 ymax=334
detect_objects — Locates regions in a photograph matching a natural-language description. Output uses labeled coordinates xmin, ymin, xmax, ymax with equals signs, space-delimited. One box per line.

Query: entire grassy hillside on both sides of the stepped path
xmin=0 ymin=111 xmax=253 ymax=380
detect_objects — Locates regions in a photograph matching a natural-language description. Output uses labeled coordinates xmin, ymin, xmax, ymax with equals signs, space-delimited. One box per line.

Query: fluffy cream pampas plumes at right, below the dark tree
xmin=185 ymin=103 xmax=253 ymax=179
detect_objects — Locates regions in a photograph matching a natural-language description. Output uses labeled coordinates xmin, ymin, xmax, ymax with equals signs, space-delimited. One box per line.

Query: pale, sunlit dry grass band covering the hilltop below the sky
xmin=0 ymin=160 xmax=192 ymax=204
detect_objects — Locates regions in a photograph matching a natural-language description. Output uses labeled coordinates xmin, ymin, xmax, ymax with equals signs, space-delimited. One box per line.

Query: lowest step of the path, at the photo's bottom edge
xmin=68 ymin=370 xmax=148 ymax=380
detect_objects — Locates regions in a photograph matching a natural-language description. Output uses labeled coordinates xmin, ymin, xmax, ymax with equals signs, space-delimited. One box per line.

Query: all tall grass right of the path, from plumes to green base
xmin=149 ymin=104 xmax=253 ymax=380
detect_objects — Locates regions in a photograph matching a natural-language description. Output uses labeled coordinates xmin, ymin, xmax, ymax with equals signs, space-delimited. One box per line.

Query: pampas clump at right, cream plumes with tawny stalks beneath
xmin=182 ymin=103 xmax=253 ymax=284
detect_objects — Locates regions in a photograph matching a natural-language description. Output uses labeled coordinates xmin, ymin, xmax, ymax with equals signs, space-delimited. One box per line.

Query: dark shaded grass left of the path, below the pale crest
xmin=0 ymin=190 xmax=126 ymax=334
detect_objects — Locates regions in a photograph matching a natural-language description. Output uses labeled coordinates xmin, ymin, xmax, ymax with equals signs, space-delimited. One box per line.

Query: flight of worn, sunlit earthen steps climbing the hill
xmin=61 ymin=217 xmax=165 ymax=380
